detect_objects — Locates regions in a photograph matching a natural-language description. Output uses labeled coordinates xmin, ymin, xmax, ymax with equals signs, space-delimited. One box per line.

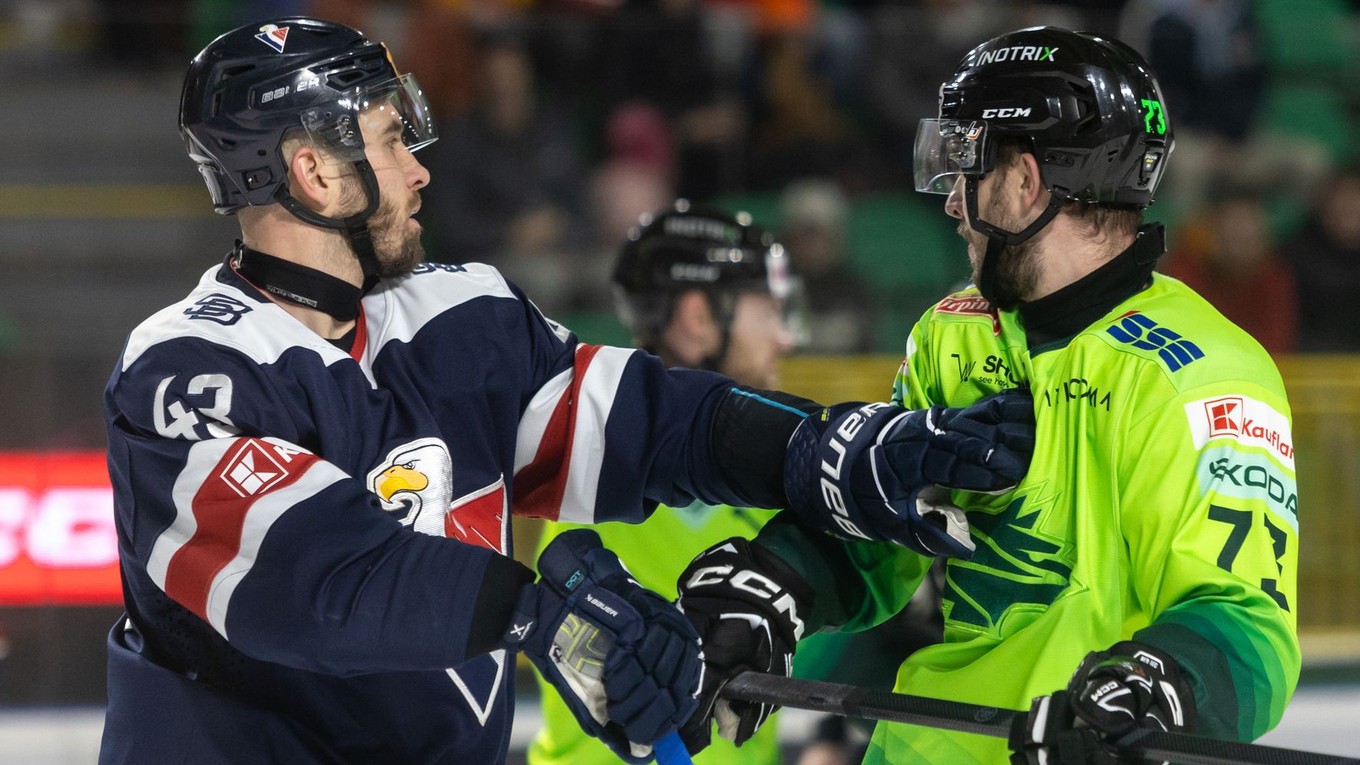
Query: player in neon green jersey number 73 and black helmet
xmin=679 ymin=27 xmax=1299 ymax=764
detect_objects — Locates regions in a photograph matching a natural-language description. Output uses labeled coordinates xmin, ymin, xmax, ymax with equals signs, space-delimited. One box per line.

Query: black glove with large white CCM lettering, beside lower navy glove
xmin=677 ymin=536 xmax=812 ymax=754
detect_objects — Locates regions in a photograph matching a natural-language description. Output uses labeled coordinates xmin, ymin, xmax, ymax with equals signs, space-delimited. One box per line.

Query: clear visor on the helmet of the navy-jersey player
xmin=302 ymin=74 xmax=439 ymax=163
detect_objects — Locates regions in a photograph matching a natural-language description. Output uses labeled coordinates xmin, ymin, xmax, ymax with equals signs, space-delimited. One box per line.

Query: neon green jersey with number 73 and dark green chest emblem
xmin=771 ymin=259 xmax=1299 ymax=765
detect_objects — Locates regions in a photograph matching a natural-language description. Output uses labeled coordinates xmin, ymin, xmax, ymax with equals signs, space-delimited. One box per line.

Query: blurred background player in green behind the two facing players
xmin=529 ymin=200 xmax=798 ymax=765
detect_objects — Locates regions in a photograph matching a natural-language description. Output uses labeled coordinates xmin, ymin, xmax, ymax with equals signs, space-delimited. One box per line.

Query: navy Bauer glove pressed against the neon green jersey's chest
xmin=783 ymin=389 xmax=1034 ymax=558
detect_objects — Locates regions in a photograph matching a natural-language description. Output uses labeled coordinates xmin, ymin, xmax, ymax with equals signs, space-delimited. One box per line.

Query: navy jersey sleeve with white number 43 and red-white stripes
xmin=106 ymin=339 xmax=532 ymax=675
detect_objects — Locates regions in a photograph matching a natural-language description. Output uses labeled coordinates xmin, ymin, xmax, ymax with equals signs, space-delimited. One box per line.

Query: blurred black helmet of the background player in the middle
xmin=613 ymin=199 xmax=798 ymax=346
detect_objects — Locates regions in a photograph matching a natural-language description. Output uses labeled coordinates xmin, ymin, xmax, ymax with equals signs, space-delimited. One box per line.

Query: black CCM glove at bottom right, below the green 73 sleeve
xmin=1010 ymin=640 xmax=1195 ymax=765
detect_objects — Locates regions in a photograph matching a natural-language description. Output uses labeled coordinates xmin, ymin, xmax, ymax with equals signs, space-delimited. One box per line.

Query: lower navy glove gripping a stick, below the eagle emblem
xmin=502 ymin=528 xmax=703 ymax=762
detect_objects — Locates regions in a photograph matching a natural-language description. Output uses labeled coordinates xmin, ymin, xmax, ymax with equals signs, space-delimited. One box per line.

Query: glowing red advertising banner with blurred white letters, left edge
xmin=0 ymin=452 xmax=122 ymax=606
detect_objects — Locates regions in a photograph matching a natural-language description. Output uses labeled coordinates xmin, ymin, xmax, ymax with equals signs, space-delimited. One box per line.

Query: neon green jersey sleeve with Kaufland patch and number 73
xmin=1118 ymin=375 xmax=1300 ymax=740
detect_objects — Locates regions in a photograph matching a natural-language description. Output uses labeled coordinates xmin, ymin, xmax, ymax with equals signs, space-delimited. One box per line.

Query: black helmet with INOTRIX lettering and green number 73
xmin=915 ymin=27 xmax=1172 ymax=207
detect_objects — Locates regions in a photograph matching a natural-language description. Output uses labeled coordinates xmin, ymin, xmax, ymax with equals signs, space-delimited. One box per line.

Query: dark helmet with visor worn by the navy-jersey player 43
xmin=180 ymin=16 xmax=437 ymax=287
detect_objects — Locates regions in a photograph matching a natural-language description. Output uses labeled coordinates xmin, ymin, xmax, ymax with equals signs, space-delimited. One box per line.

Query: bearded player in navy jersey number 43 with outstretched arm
xmin=101 ymin=18 xmax=1032 ymax=765
